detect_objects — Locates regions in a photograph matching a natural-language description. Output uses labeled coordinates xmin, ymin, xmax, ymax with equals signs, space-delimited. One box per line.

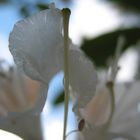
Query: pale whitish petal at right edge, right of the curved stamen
xmin=110 ymin=82 xmax=140 ymax=139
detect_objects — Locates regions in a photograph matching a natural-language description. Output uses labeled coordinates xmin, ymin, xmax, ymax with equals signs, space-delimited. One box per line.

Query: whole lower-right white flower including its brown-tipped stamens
xmin=73 ymin=38 xmax=140 ymax=140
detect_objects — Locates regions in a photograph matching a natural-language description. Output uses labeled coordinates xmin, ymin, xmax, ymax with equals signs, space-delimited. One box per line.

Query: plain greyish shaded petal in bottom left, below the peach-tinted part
xmin=0 ymin=111 xmax=43 ymax=140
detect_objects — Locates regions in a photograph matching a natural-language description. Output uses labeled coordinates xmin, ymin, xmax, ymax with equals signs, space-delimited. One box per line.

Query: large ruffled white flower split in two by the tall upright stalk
xmin=9 ymin=4 xmax=96 ymax=113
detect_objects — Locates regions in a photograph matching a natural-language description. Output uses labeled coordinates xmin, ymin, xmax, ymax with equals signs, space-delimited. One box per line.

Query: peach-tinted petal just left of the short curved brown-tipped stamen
xmin=83 ymin=85 xmax=111 ymax=126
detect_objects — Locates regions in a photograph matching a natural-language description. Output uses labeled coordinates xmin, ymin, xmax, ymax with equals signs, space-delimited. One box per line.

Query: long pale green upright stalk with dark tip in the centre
xmin=62 ymin=8 xmax=71 ymax=140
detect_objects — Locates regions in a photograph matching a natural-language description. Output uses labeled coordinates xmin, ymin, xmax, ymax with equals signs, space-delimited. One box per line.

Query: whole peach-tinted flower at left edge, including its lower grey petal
xmin=0 ymin=62 xmax=42 ymax=140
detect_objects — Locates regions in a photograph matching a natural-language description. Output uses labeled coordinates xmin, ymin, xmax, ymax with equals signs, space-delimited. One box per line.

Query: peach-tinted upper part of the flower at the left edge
xmin=0 ymin=64 xmax=39 ymax=117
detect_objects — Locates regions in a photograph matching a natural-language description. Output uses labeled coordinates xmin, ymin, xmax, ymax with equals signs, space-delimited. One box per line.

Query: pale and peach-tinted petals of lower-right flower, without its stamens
xmin=78 ymin=82 xmax=140 ymax=140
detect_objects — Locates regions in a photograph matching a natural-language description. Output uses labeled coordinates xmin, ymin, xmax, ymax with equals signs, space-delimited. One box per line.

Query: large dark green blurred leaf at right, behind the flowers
xmin=81 ymin=28 xmax=140 ymax=67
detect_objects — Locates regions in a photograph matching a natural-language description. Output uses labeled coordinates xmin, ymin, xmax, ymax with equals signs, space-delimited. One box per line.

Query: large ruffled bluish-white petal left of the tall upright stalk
xmin=9 ymin=8 xmax=63 ymax=84
